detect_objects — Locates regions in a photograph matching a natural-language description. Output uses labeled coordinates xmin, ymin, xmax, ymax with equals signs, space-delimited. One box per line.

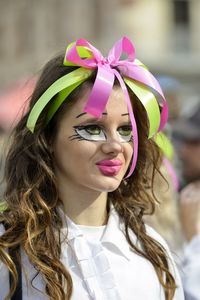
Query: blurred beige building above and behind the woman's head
xmin=0 ymin=0 xmax=200 ymax=100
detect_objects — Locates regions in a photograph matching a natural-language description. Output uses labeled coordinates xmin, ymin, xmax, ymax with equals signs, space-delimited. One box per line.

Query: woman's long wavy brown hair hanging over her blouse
xmin=0 ymin=55 xmax=176 ymax=300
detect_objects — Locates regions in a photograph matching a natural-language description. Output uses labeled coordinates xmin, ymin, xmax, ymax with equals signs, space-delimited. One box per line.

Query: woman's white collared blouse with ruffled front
xmin=0 ymin=207 xmax=184 ymax=300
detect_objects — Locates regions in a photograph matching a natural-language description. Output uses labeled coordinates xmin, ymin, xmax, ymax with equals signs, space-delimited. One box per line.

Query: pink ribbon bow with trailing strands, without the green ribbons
xmin=65 ymin=37 xmax=168 ymax=178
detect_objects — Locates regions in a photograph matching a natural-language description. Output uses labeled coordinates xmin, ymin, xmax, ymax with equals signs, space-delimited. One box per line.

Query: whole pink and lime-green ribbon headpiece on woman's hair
xmin=27 ymin=37 xmax=168 ymax=177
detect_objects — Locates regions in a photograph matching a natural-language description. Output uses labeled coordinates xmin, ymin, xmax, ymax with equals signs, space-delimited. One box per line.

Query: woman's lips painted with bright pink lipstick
xmin=96 ymin=159 xmax=122 ymax=176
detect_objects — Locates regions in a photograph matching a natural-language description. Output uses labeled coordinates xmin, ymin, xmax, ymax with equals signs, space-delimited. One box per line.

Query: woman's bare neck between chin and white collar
xmin=58 ymin=178 xmax=108 ymax=226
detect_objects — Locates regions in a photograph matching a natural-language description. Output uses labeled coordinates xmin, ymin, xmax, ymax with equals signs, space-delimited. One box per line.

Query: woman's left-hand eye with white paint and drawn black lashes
xmin=70 ymin=124 xmax=106 ymax=142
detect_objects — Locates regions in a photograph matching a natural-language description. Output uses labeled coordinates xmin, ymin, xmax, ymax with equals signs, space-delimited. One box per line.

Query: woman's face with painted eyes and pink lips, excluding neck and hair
xmin=53 ymin=87 xmax=133 ymax=192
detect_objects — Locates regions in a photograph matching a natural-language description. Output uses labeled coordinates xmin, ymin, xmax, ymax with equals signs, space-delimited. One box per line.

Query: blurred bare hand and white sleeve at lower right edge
xmin=180 ymin=180 xmax=200 ymax=300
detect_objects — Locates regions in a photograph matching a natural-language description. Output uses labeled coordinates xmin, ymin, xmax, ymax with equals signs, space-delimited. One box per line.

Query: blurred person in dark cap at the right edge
xmin=173 ymin=102 xmax=200 ymax=300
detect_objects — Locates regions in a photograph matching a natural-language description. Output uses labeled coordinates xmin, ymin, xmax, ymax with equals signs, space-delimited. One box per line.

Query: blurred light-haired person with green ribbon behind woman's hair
xmin=146 ymin=131 xmax=184 ymax=253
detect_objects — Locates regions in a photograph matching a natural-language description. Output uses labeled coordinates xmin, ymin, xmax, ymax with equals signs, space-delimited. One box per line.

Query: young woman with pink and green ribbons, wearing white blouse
xmin=0 ymin=38 xmax=184 ymax=300
